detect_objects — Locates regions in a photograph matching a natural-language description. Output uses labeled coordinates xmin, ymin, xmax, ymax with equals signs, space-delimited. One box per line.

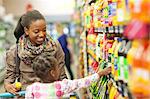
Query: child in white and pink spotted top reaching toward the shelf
xmin=25 ymin=53 xmax=111 ymax=99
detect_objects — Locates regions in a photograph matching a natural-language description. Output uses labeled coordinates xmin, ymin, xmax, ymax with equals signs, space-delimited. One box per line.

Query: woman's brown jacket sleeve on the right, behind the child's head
xmin=55 ymin=41 xmax=67 ymax=80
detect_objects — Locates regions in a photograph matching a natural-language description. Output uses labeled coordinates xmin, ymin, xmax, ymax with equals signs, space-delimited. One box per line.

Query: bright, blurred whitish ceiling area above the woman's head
xmin=3 ymin=0 xmax=75 ymax=21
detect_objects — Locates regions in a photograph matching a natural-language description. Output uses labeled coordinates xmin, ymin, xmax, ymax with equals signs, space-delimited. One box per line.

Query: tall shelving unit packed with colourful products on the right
xmin=78 ymin=0 xmax=150 ymax=99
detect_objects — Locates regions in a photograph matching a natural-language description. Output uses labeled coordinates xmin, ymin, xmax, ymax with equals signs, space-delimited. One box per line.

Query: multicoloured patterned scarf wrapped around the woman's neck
xmin=18 ymin=35 xmax=56 ymax=65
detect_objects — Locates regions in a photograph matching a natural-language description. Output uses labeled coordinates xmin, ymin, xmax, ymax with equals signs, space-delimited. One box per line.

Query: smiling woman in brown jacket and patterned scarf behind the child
xmin=5 ymin=10 xmax=66 ymax=94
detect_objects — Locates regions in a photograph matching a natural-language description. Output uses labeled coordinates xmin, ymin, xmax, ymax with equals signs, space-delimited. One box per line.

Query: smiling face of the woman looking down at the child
xmin=25 ymin=19 xmax=46 ymax=45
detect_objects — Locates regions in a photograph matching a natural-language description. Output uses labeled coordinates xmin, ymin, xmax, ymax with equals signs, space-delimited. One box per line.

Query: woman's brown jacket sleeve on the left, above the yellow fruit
xmin=4 ymin=47 xmax=16 ymax=83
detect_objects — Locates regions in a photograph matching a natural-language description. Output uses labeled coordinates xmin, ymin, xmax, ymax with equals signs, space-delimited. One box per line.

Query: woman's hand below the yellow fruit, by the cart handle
xmin=5 ymin=83 xmax=19 ymax=95
